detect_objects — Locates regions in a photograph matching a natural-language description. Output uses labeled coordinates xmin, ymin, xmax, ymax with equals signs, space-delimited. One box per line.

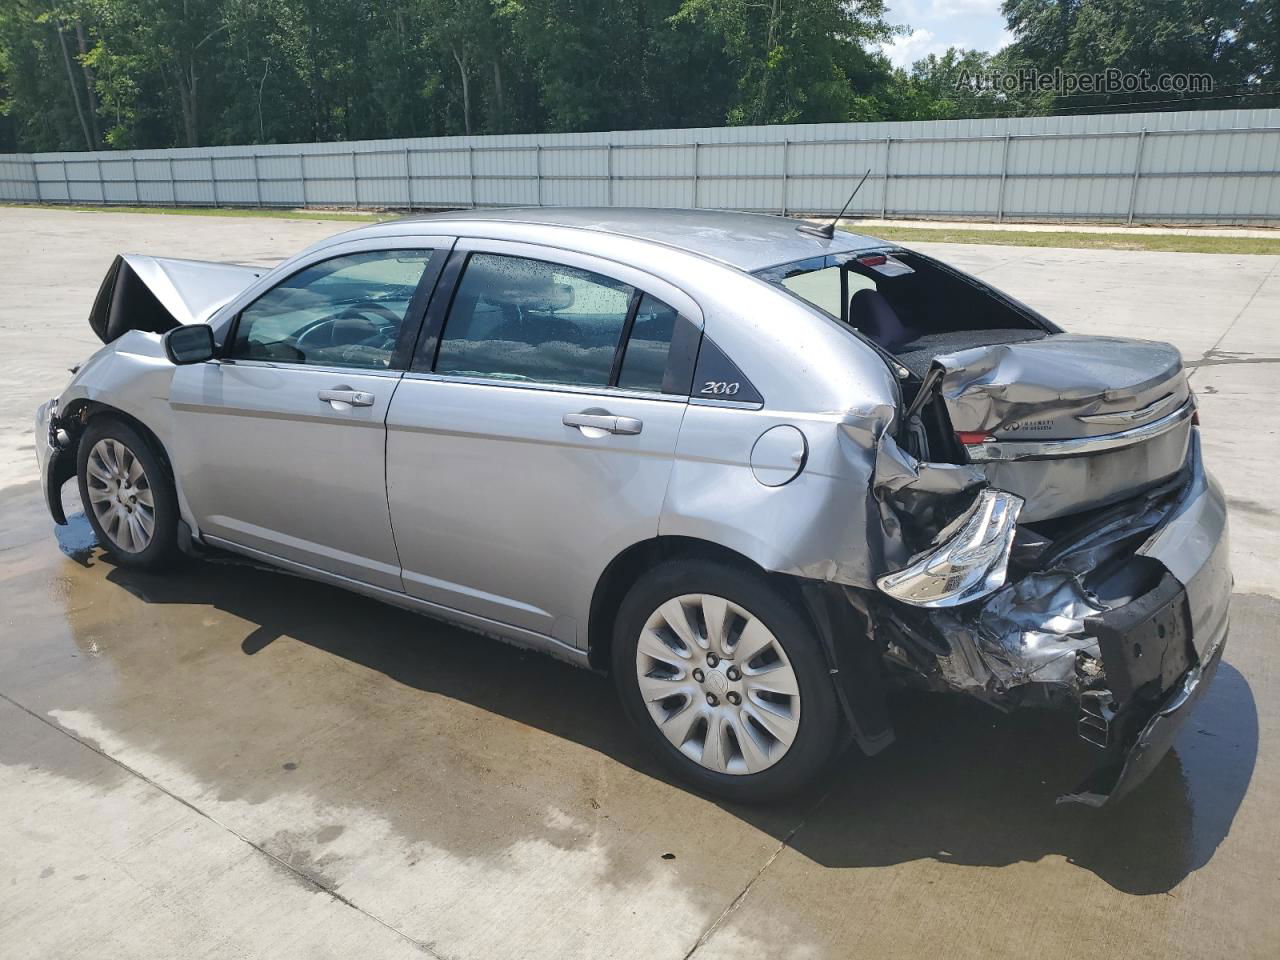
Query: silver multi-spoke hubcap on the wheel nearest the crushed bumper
xmin=636 ymin=594 xmax=800 ymax=774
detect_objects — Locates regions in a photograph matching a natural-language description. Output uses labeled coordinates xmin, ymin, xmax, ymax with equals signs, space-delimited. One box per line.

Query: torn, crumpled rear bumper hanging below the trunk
xmin=874 ymin=428 xmax=1233 ymax=806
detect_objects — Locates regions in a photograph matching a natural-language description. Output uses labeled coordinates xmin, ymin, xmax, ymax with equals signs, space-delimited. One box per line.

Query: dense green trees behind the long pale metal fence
xmin=0 ymin=0 xmax=1280 ymax=150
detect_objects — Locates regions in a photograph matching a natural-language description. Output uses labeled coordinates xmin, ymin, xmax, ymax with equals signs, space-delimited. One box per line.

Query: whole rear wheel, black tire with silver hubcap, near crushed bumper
xmin=612 ymin=561 xmax=840 ymax=801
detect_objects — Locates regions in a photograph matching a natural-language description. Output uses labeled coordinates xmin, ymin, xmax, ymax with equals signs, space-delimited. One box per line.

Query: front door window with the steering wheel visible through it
xmin=232 ymin=250 xmax=433 ymax=370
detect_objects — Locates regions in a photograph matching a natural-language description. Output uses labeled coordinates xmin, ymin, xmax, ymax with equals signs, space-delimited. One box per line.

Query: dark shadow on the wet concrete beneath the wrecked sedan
xmin=95 ymin=537 xmax=1259 ymax=895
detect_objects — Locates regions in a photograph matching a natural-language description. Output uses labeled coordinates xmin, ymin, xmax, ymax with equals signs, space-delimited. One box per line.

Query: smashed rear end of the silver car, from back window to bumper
xmin=767 ymin=250 xmax=1231 ymax=806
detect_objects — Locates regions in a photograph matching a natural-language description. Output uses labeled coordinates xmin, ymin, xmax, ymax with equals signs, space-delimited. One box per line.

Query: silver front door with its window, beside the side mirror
xmin=170 ymin=248 xmax=444 ymax=590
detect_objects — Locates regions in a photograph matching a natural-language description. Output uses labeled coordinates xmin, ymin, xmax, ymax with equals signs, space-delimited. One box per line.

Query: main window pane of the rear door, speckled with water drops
xmin=435 ymin=253 xmax=635 ymax=387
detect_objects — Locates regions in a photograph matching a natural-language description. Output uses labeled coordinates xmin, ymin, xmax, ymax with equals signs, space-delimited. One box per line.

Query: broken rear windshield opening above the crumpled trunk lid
xmin=755 ymin=250 xmax=1044 ymax=355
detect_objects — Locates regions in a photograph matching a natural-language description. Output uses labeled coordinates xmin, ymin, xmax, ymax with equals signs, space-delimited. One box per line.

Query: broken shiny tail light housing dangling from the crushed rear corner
xmin=876 ymin=488 xmax=1023 ymax=608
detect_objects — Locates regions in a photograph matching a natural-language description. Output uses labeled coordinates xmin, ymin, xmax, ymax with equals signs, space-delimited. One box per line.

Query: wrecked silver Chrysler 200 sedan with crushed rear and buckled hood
xmin=37 ymin=209 xmax=1230 ymax=805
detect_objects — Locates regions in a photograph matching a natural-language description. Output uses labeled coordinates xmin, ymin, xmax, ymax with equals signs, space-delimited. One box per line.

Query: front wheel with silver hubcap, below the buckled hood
xmin=77 ymin=419 xmax=178 ymax=568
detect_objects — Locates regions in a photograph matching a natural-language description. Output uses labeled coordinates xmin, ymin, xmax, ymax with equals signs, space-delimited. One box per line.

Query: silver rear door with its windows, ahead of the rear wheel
xmin=387 ymin=239 xmax=701 ymax=645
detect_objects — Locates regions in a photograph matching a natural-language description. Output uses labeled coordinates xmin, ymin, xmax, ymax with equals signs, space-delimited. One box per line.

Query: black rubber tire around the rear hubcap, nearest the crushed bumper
xmin=611 ymin=559 xmax=842 ymax=803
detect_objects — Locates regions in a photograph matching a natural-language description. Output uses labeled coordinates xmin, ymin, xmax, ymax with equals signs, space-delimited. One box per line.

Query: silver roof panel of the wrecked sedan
xmin=350 ymin=206 xmax=887 ymax=273
